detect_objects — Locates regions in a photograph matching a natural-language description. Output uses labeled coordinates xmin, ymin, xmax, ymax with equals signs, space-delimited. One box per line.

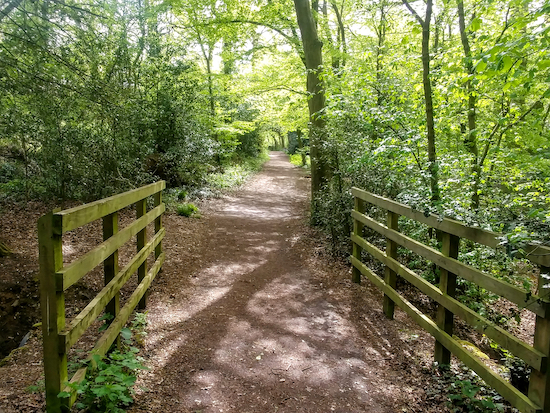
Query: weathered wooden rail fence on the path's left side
xmin=38 ymin=181 xmax=165 ymax=413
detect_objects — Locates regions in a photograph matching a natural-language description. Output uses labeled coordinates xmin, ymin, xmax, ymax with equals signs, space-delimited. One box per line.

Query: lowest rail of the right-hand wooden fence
xmin=351 ymin=257 xmax=543 ymax=413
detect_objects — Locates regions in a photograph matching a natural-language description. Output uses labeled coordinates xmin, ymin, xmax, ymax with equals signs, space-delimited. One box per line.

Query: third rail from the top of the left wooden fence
xmin=59 ymin=228 xmax=166 ymax=351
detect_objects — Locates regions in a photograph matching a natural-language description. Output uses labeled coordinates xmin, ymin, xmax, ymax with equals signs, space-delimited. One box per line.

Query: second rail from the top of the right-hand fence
xmin=352 ymin=211 xmax=549 ymax=317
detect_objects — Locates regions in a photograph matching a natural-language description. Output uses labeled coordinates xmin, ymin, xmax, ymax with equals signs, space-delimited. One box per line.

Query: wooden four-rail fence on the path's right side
xmin=351 ymin=188 xmax=550 ymax=413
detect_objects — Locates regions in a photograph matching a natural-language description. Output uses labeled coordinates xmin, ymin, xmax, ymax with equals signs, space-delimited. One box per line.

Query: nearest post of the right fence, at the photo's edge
xmin=528 ymin=266 xmax=550 ymax=413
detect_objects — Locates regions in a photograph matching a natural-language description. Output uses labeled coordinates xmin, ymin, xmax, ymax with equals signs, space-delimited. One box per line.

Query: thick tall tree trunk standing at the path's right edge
xmin=294 ymin=0 xmax=329 ymax=201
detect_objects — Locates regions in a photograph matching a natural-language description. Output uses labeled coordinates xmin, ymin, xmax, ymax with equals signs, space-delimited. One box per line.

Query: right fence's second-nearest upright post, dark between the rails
xmin=434 ymin=232 xmax=460 ymax=366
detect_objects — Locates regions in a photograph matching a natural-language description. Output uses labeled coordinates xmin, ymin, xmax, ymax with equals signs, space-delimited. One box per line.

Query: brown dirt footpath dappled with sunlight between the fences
xmin=130 ymin=153 xmax=440 ymax=413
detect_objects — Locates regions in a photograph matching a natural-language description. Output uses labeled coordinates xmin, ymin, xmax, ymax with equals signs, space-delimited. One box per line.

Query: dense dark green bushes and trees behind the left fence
xmin=0 ymin=0 xmax=272 ymax=200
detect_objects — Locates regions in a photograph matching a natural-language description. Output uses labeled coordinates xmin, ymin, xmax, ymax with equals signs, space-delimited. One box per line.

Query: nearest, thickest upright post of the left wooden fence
xmin=38 ymin=212 xmax=68 ymax=413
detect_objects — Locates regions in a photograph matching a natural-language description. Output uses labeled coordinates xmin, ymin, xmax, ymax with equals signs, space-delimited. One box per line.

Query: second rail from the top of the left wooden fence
xmin=56 ymin=204 xmax=165 ymax=291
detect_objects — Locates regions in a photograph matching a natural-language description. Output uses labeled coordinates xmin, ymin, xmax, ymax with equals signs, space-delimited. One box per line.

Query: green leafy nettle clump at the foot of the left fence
xmin=58 ymin=313 xmax=147 ymax=413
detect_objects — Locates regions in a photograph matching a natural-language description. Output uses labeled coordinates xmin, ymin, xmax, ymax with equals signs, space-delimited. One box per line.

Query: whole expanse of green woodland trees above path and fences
xmin=0 ymin=0 xmax=550 ymax=242
